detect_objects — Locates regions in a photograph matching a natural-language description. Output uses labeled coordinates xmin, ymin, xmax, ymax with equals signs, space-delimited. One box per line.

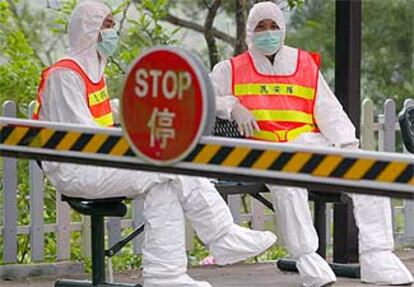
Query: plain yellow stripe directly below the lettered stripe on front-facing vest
xmin=252 ymin=110 xmax=313 ymax=124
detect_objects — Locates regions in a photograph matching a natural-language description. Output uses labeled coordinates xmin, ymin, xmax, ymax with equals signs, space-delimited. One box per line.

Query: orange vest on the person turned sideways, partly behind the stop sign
xmin=33 ymin=59 xmax=114 ymax=127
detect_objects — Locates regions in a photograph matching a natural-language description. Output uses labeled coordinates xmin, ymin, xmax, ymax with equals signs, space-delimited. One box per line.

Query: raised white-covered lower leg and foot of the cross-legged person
xmin=175 ymin=176 xmax=276 ymax=265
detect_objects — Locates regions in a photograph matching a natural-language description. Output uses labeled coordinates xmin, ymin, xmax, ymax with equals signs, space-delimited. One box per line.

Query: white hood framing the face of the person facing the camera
xmin=246 ymin=1 xmax=286 ymax=55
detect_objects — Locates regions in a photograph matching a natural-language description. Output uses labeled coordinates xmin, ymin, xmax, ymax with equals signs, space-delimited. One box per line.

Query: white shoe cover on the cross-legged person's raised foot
xmin=209 ymin=224 xmax=277 ymax=265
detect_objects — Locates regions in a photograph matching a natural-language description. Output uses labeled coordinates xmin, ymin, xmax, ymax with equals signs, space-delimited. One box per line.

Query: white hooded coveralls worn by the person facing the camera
xmin=210 ymin=2 xmax=394 ymax=270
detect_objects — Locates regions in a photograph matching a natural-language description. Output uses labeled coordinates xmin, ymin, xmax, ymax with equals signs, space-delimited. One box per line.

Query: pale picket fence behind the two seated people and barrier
xmin=0 ymin=99 xmax=414 ymax=263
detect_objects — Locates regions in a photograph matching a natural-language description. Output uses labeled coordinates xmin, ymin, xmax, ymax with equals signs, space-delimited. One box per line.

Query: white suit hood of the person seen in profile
xmin=68 ymin=1 xmax=111 ymax=83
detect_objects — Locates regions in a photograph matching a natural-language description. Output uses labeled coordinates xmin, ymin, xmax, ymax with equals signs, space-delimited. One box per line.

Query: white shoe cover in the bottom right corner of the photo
xmin=359 ymin=251 xmax=413 ymax=286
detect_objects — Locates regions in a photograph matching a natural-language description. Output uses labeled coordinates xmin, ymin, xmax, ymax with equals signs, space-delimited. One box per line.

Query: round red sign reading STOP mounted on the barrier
xmin=121 ymin=48 xmax=207 ymax=164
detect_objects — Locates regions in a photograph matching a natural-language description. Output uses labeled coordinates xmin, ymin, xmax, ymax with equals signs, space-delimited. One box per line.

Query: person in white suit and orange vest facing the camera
xmin=210 ymin=2 xmax=413 ymax=286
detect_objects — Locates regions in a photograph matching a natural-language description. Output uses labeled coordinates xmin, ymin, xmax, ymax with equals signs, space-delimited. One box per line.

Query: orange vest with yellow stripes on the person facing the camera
xmin=231 ymin=50 xmax=320 ymax=142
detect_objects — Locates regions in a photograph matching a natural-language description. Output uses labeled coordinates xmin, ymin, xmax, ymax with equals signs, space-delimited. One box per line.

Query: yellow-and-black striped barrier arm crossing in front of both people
xmin=0 ymin=117 xmax=414 ymax=199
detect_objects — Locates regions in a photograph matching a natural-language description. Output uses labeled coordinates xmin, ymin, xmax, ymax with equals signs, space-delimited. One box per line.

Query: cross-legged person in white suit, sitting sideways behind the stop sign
xmin=34 ymin=1 xmax=276 ymax=287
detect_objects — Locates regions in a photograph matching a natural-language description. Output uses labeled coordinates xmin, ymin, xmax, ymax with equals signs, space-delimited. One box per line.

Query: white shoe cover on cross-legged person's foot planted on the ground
xmin=144 ymin=274 xmax=212 ymax=287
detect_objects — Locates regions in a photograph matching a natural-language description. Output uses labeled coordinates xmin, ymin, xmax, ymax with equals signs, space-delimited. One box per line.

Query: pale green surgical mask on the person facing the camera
xmin=253 ymin=30 xmax=282 ymax=56
